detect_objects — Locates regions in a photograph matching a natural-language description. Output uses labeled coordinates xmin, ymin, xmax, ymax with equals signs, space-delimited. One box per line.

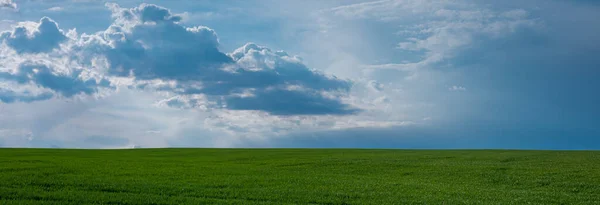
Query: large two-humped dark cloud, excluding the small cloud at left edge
xmin=93 ymin=4 xmax=355 ymax=115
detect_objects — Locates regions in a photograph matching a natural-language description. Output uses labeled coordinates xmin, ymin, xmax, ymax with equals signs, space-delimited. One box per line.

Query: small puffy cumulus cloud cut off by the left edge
xmin=0 ymin=17 xmax=111 ymax=103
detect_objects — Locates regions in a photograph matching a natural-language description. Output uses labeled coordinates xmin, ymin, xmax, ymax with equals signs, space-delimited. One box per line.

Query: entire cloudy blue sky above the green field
xmin=0 ymin=0 xmax=600 ymax=150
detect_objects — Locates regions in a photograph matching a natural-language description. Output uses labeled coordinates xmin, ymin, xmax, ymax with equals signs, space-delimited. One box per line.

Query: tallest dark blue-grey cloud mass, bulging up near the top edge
xmin=83 ymin=4 xmax=232 ymax=80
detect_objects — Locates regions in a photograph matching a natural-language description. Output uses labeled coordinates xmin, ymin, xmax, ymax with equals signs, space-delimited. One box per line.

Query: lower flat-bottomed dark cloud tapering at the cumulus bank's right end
xmin=152 ymin=44 xmax=359 ymax=115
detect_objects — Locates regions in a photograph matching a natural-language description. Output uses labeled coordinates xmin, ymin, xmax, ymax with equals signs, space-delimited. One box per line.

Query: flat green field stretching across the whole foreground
xmin=0 ymin=149 xmax=600 ymax=204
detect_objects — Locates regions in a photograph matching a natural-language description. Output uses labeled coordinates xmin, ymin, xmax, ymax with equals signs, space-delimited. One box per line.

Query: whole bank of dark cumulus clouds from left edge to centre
xmin=1 ymin=3 xmax=359 ymax=115
